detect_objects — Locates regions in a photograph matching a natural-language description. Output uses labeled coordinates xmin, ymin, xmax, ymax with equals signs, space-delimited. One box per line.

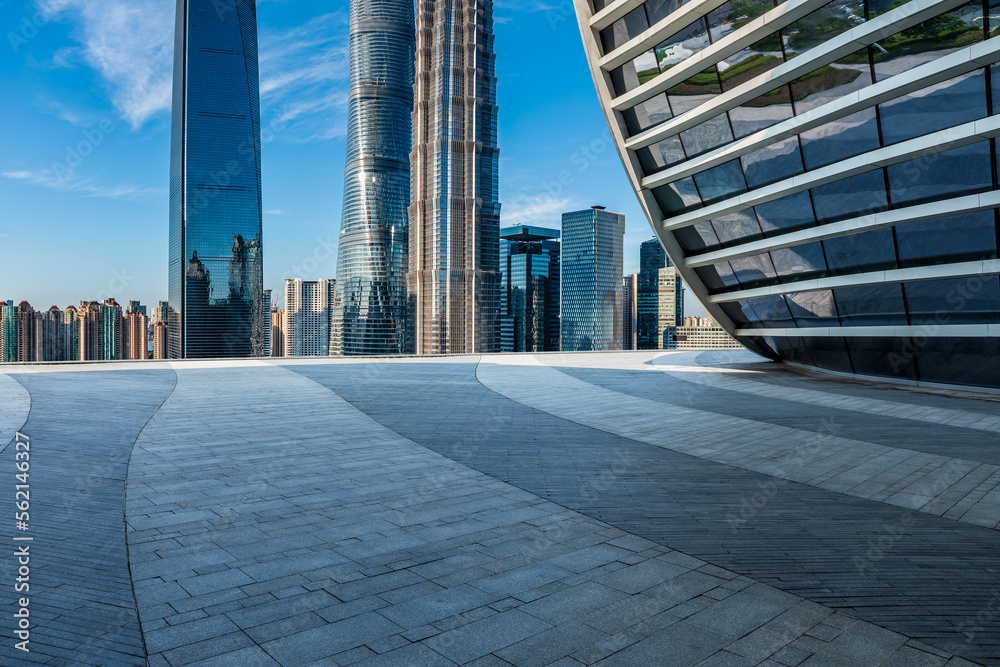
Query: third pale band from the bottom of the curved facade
xmin=684 ymin=189 xmax=1000 ymax=268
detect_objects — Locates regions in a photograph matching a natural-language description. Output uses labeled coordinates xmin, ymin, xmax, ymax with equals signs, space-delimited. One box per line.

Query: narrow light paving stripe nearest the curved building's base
xmin=652 ymin=352 xmax=1000 ymax=433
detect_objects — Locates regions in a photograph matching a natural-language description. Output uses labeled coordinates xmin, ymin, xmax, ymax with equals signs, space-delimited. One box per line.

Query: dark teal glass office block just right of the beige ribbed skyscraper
xmin=500 ymin=225 xmax=560 ymax=352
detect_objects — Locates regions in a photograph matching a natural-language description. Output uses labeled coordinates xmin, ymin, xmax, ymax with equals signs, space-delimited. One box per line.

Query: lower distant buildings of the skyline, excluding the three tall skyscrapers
xmin=0 ymin=206 xmax=742 ymax=362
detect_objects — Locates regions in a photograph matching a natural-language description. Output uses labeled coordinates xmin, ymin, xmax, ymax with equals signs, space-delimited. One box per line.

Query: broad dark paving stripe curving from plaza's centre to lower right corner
xmin=290 ymin=355 xmax=1000 ymax=665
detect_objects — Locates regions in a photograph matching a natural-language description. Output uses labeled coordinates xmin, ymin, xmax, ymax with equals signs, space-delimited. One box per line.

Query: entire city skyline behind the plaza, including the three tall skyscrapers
xmin=0 ymin=0 xmax=738 ymax=362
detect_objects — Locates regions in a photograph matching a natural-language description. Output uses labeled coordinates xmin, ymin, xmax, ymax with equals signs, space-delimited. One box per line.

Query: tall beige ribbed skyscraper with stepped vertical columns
xmin=407 ymin=0 xmax=500 ymax=354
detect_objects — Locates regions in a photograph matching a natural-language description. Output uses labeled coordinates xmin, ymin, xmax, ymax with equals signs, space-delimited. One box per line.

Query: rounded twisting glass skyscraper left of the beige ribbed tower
xmin=331 ymin=0 xmax=414 ymax=355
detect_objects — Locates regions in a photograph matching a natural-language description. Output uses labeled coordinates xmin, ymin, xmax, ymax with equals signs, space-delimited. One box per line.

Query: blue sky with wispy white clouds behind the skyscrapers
xmin=0 ymin=0 xmax=701 ymax=312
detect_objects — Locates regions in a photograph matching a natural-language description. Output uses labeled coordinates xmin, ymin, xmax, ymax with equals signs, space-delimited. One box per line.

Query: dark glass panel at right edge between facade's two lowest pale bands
xmin=903 ymin=276 xmax=1000 ymax=325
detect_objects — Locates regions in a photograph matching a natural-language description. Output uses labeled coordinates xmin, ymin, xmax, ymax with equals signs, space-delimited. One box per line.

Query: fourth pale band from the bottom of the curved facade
xmin=662 ymin=116 xmax=1000 ymax=231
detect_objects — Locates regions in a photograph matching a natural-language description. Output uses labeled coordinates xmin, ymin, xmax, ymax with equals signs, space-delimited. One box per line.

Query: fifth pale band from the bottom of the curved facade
xmin=625 ymin=39 xmax=1000 ymax=184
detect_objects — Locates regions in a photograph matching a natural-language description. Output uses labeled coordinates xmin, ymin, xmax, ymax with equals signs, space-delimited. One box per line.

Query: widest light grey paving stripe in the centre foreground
xmin=121 ymin=362 xmax=972 ymax=667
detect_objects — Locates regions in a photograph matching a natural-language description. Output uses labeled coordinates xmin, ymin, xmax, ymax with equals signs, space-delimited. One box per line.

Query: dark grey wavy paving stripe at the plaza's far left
xmin=0 ymin=367 xmax=174 ymax=667
